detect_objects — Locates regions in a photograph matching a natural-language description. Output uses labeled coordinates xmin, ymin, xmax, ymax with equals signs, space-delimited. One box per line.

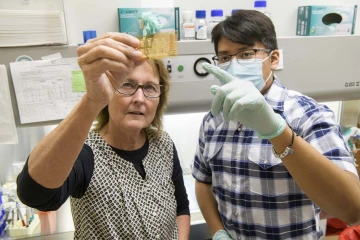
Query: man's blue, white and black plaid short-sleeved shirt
xmin=192 ymin=78 xmax=357 ymax=239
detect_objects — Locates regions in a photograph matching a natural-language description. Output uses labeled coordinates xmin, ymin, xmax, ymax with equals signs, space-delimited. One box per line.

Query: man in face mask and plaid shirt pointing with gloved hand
xmin=192 ymin=10 xmax=360 ymax=240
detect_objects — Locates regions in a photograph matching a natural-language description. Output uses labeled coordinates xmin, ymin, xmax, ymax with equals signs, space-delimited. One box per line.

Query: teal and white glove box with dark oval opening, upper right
xmin=296 ymin=5 xmax=357 ymax=36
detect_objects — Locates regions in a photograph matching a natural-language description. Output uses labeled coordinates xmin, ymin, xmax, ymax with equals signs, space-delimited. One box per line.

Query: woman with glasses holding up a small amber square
xmin=17 ymin=33 xmax=190 ymax=239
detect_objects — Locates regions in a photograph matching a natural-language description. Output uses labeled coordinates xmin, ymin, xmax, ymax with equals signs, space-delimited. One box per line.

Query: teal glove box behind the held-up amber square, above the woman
xmin=118 ymin=7 xmax=180 ymax=41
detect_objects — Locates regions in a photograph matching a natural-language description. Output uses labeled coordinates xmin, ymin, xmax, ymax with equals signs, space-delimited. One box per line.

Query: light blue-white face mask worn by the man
xmin=218 ymin=52 xmax=272 ymax=91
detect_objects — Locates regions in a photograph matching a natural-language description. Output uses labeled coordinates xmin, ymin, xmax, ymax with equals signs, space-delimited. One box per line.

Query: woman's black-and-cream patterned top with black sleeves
xmin=17 ymin=131 xmax=189 ymax=239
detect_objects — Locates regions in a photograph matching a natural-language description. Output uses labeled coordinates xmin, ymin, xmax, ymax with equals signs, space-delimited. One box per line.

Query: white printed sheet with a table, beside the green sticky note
xmin=10 ymin=58 xmax=84 ymax=123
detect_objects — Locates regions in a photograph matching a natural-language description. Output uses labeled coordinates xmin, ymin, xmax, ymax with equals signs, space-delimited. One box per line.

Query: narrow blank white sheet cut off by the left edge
xmin=0 ymin=65 xmax=18 ymax=144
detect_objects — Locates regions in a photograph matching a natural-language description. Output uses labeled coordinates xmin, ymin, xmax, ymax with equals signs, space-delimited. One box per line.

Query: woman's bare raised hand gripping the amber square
xmin=77 ymin=33 xmax=144 ymax=106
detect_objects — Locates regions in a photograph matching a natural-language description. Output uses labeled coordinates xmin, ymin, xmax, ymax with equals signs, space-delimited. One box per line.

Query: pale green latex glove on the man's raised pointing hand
xmin=202 ymin=63 xmax=286 ymax=139
